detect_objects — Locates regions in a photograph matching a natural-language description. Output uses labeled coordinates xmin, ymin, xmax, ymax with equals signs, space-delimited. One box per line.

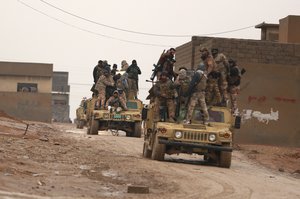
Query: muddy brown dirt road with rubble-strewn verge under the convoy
xmin=0 ymin=118 xmax=300 ymax=199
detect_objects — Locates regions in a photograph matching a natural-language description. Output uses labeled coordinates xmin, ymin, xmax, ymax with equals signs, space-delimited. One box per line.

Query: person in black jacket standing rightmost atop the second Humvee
xmin=126 ymin=60 xmax=142 ymax=99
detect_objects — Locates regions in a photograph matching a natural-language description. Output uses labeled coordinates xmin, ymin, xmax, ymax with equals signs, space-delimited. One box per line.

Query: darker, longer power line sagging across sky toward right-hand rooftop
xmin=40 ymin=0 xmax=255 ymax=37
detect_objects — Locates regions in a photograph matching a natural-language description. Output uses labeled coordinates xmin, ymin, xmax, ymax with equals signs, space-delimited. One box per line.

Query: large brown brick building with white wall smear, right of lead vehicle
xmin=175 ymin=16 xmax=300 ymax=147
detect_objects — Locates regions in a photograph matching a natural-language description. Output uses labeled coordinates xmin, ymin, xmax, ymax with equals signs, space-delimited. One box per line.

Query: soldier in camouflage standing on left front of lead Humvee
xmin=153 ymin=72 xmax=175 ymax=122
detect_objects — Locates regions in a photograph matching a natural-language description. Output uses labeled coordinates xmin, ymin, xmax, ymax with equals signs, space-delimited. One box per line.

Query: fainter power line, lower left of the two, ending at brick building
xmin=18 ymin=0 xmax=171 ymax=47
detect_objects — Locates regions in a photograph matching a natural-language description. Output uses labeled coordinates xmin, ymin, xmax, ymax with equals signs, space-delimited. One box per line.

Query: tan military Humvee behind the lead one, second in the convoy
xmin=87 ymin=99 xmax=143 ymax=137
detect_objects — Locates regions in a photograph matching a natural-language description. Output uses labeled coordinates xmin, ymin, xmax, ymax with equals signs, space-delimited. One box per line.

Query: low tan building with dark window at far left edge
xmin=0 ymin=62 xmax=53 ymax=122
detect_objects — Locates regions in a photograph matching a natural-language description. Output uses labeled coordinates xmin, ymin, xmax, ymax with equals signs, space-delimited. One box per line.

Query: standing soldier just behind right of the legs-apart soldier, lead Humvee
xmin=200 ymin=48 xmax=222 ymax=104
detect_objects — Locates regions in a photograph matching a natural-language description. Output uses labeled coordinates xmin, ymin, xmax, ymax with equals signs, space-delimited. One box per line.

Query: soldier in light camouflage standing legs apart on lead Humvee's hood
xmin=184 ymin=69 xmax=209 ymax=125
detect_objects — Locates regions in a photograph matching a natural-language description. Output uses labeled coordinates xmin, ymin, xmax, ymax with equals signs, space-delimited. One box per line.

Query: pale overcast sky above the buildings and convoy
xmin=0 ymin=0 xmax=300 ymax=119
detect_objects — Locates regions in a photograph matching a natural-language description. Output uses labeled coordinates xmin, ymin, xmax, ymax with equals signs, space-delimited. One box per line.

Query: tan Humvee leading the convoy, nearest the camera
xmin=143 ymin=104 xmax=240 ymax=168
